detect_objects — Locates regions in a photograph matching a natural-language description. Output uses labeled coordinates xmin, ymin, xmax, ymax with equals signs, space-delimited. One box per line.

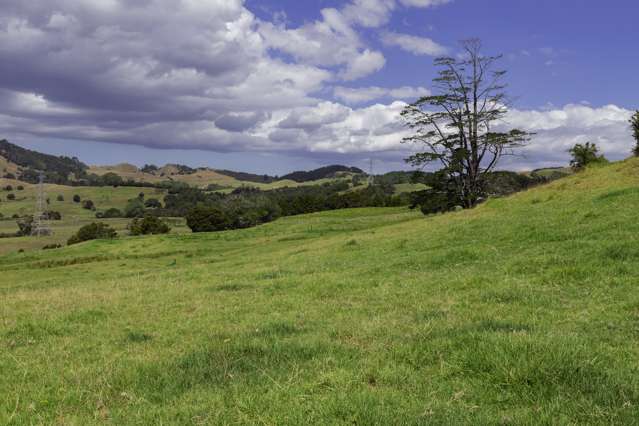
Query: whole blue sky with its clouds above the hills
xmin=0 ymin=0 xmax=639 ymax=174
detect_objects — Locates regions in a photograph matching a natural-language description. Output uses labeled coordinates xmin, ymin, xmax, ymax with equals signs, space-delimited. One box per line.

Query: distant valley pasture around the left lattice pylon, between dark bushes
xmin=0 ymin=179 xmax=189 ymax=255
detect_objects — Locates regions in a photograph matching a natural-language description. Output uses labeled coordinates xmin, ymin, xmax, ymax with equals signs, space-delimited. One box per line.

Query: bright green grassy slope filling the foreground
xmin=0 ymin=160 xmax=639 ymax=425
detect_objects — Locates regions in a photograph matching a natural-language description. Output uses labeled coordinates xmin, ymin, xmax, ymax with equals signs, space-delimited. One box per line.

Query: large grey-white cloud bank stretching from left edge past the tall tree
xmin=0 ymin=0 xmax=632 ymax=168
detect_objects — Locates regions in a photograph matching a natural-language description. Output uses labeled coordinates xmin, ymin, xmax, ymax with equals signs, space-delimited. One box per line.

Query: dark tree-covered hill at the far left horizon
xmin=0 ymin=139 xmax=88 ymax=183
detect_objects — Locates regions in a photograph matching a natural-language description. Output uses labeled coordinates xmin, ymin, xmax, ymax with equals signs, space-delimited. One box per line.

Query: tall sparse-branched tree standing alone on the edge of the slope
xmin=402 ymin=39 xmax=531 ymax=208
